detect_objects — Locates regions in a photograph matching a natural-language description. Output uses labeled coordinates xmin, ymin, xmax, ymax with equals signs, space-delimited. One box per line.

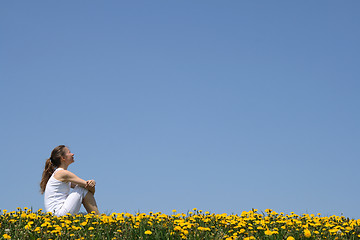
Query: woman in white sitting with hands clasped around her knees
xmin=40 ymin=145 xmax=99 ymax=216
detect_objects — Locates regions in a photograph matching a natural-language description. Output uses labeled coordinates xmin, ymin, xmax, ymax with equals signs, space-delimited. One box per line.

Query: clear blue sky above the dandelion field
xmin=0 ymin=0 xmax=360 ymax=218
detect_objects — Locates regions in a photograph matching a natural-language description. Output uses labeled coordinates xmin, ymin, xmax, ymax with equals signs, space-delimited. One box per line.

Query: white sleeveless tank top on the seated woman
xmin=44 ymin=168 xmax=71 ymax=213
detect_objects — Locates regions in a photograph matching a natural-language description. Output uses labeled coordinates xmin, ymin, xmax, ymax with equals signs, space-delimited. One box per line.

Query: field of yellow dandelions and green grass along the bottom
xmin=0 ymin=208 xmax=360 ymax=240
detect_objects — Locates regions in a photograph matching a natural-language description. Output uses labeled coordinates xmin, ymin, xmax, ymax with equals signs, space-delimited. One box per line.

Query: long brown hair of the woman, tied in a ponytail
xmin=40 ymin=145 xmax=66 ymax=194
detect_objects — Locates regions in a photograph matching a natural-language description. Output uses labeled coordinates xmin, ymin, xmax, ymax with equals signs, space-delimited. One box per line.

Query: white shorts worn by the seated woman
xmin=55 ymin=185 xmax=88 ymax=217
